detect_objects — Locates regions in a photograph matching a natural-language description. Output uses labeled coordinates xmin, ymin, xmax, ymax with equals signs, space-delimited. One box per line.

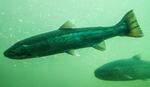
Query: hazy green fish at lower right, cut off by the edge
xmin=94 ymin=55 xmax=150 ymax=81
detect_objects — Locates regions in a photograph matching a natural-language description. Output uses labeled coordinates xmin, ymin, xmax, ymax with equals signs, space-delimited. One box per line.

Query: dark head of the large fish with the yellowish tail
xmin=4 ymin=43 xmax=32 ymax=59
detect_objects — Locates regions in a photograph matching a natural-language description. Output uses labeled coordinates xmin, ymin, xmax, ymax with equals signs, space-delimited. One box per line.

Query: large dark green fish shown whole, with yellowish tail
xmin=3 ymin=10 xmax=143 ymax=59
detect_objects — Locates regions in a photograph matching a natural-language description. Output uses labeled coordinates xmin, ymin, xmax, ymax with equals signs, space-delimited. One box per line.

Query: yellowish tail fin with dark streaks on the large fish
xmin=118 ymin=10 xmax=143 ymax=37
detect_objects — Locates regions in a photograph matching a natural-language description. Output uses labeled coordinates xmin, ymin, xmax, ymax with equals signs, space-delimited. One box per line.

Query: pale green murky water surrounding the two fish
xmin=0 ymin=0 xmax=150 ymax=87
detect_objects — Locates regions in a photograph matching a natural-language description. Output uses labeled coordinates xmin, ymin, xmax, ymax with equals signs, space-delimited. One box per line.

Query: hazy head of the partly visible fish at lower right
xmin=94 ymin=62 xmax=129 ymax=81
